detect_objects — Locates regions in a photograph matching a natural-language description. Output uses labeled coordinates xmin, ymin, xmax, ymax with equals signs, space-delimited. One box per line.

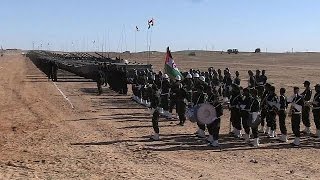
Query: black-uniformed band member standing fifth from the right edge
xmin=267 ymin=86 xmax=278 ymax=138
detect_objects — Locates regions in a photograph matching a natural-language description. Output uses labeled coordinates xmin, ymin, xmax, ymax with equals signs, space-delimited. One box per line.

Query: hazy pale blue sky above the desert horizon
xmin=0 ymin=0 xmax=320 ymax=52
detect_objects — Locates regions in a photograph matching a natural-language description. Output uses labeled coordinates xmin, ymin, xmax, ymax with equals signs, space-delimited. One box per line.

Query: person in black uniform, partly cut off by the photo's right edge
xmin=312 ymin=84 xmax=320 ymax=139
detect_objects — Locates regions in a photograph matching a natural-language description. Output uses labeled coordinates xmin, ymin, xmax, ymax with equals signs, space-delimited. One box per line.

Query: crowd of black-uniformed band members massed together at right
xmin=132 ymin=67 xmax=320 ymax=147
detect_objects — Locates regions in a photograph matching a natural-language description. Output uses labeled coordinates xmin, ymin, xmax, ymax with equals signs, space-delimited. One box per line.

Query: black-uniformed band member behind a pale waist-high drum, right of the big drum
xmin=250 ymin=89 xmax=260 ymax=147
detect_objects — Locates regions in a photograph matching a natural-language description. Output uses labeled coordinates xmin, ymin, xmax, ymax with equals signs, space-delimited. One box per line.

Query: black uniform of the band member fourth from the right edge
xmin=278 ymin=95 xmax=288 ymax=135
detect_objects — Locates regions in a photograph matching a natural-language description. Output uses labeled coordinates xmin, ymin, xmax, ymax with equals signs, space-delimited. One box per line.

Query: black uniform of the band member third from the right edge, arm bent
xmin=291 ymin=94 xmax=304 ymax=137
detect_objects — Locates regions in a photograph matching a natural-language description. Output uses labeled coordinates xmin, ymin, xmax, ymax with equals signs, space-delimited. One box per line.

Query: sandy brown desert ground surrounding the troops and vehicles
xmin=0 ymin=52 xmax=320 ymax=180
